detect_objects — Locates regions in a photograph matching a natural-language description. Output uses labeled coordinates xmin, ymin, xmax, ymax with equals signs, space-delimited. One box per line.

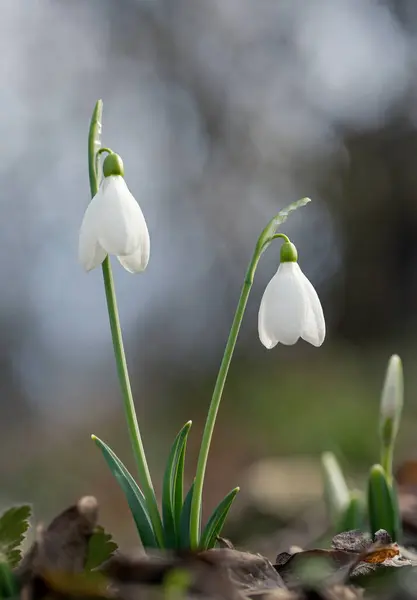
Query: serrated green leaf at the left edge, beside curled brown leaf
xmin=0 ymin=504 xmax=31 ymax=567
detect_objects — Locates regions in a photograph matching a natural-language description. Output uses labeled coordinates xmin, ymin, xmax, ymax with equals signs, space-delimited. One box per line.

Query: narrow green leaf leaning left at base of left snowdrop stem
xmin=91 ymin=435 xmax=159 ymax=548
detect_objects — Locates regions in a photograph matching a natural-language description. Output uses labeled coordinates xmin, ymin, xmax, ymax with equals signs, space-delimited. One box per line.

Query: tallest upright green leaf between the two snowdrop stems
xmin=162 ymin=421 xmax=191 ymax=548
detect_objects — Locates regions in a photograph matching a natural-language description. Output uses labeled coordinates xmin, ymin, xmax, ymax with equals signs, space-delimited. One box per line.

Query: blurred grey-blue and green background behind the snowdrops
xmin=0 ymin=0 xmax=417 ymax=550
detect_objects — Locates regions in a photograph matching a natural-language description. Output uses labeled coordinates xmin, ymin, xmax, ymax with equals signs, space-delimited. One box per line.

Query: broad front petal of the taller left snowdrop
xmin=97 ymin=175 xmax=149 ymax=256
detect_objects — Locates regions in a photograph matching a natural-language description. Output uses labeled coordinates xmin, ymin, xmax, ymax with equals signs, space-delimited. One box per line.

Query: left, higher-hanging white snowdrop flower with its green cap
xmin=78 ymin=153 xmax=150 ymax=273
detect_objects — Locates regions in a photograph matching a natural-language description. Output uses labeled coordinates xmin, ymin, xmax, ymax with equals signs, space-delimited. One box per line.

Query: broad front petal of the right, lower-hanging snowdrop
xmin=258 ymin=262 xmax=306 ymax=349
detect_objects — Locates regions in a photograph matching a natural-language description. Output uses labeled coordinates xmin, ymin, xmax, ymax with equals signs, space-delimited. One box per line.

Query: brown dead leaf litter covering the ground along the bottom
xmin=3 ymin=496 xmax=417 ymax=600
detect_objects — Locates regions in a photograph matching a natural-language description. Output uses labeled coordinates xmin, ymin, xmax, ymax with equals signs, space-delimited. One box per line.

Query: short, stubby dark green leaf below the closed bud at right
xmin=368 ymin=465 xmax=400 ymax=542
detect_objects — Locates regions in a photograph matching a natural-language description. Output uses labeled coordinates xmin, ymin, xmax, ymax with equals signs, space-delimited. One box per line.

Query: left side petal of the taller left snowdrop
xmin=78 ymin=194 xmax=107 ymax=271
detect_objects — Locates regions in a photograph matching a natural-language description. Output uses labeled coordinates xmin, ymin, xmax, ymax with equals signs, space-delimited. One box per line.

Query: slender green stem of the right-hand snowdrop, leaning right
xmin=190 ymin=243 xmax=262 ymax=549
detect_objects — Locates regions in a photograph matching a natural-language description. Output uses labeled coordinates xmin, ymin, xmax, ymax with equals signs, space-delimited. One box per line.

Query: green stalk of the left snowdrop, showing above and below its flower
xmin=88 ymin=100 xmax=164 ymax=547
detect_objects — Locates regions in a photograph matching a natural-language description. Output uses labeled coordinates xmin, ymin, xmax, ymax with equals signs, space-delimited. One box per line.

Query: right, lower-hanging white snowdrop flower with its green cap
xmin=258 ymin=241 xmax=326 ymax=349
